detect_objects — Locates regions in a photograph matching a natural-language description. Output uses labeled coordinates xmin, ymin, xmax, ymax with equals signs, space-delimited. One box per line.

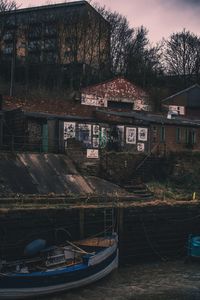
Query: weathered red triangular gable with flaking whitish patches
xmin=82 ymin=77 xmax=148 ymax=101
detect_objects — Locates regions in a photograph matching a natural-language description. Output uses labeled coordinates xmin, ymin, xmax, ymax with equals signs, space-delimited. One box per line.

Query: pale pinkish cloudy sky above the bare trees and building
xmin=17 ymin=0 xmax=200 ymax=44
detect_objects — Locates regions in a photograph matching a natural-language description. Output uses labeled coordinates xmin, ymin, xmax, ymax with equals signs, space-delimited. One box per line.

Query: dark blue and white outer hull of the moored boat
xmin=0 ymin=245 xmax=118 ymax=299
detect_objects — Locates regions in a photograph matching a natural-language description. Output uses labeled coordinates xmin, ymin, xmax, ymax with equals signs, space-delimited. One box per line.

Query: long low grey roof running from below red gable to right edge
xmin=97 ymin=109 xmax=200 ymax=127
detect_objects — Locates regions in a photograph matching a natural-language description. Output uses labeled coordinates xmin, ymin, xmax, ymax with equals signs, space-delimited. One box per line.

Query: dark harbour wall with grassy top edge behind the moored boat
xmin=0 ymin=201 xmax=200 ymax=264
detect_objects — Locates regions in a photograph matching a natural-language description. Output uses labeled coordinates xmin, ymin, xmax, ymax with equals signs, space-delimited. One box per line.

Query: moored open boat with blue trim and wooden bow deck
xmin=0 ymin=233 xmax=118 ymax=299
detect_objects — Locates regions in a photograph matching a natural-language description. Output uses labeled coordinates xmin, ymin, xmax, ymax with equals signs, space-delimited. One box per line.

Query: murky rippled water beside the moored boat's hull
xmin=37 ymin=261 xmax=200 ymax=300
